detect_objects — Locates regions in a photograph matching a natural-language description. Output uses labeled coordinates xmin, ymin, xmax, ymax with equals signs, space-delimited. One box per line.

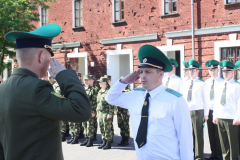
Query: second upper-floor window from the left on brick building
xmin=74 ymin=0 xmax=83 ymax=27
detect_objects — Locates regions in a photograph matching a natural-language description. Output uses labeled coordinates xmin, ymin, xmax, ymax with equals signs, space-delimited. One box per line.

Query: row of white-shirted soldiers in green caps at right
xmin=163 ymin=58 xmax=240 ymax=160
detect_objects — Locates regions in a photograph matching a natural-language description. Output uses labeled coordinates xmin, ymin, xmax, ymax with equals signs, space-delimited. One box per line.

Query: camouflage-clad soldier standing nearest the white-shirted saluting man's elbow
xmin=97 ymin=77 xmax=114 ymax=149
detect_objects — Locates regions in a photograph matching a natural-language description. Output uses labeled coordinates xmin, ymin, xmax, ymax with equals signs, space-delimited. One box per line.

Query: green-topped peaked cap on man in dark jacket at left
xmin=5 ymin=23 xmax=61 ymax=56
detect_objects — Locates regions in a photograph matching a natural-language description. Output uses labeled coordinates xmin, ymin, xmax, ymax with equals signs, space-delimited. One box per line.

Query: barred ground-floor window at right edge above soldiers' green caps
xmin=221 ymin=47 xmax=240 ymax=79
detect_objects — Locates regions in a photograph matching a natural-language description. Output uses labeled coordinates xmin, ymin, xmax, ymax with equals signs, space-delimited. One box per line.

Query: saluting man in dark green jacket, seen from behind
xmin=0 ymin=24 xmax=91 ymax=160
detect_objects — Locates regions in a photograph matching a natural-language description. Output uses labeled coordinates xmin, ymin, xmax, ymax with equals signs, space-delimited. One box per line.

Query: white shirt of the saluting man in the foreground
xmin=105 ymin=82 xmax=193 ymax=160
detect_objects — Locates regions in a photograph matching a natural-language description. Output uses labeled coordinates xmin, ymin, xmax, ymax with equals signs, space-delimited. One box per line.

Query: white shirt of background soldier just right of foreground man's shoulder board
xmin=183 ymin=77 xmax=209 ymax=116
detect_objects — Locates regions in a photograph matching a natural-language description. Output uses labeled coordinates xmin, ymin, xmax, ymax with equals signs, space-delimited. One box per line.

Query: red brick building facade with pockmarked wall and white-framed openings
xmin=31 ymin=0 xmax=240 ymax=86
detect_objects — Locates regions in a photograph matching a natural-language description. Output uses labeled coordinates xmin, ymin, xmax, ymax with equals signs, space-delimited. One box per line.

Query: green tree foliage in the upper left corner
xmin=0 ymin=0 xmax=54 ymax=74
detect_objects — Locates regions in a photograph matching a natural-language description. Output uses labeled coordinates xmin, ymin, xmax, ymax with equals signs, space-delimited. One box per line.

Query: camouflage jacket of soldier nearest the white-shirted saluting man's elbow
xmin=97 ymin=88 xmax=114 ymax=115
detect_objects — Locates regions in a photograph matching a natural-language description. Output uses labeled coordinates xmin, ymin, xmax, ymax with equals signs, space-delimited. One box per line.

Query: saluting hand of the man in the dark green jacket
xmin=48 ymin=58 xmax=66 ymax=78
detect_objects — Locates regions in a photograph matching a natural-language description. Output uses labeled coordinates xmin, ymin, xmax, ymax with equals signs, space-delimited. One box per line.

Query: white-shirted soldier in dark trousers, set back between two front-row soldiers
xmin=205 ymin=59 xmax=223 ymax=160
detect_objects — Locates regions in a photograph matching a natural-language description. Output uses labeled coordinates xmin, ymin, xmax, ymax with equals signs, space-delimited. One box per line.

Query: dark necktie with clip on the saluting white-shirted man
xmin=136 ymin=93 xmax=150 ymax=148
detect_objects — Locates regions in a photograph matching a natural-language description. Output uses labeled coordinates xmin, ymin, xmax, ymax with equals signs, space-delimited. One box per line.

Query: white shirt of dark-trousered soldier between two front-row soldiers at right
xmin=205 ymin=76 xmax=224 ymax=110
